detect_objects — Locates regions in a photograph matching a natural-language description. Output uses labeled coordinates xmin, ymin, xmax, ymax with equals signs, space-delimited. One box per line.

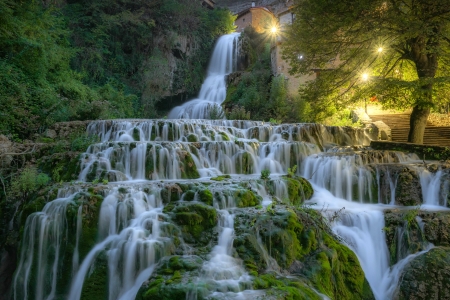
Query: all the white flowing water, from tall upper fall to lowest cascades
xmin=13 ymin=34 xmax=448 ymax=300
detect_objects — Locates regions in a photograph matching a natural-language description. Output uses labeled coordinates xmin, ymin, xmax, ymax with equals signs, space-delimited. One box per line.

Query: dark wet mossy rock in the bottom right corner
xmin=394 ymin=247 xmax=450 ymax=300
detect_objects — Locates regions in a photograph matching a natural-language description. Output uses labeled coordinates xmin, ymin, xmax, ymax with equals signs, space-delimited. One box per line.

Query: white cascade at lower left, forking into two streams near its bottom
xmin=68 ymin=188 xmax=173 ymax=300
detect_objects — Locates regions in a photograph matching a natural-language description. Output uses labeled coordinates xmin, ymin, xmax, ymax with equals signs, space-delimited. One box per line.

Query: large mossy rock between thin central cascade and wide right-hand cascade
xmin=234 ymin=205 xmax=374 ymax=299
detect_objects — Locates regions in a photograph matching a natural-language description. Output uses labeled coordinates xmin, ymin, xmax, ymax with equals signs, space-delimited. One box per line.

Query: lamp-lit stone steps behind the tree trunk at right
xmin=369 ymin=113 xmax=450 ymax=146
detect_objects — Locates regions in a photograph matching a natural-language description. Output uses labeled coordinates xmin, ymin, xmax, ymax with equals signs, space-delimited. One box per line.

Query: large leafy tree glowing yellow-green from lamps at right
xmin=284 ymin=0 xmax=450 ymax=143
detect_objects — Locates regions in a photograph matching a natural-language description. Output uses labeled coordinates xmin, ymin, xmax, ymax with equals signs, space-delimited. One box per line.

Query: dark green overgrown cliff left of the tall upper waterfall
xmin=0 ymin=0 xmax=234 ymax=140
